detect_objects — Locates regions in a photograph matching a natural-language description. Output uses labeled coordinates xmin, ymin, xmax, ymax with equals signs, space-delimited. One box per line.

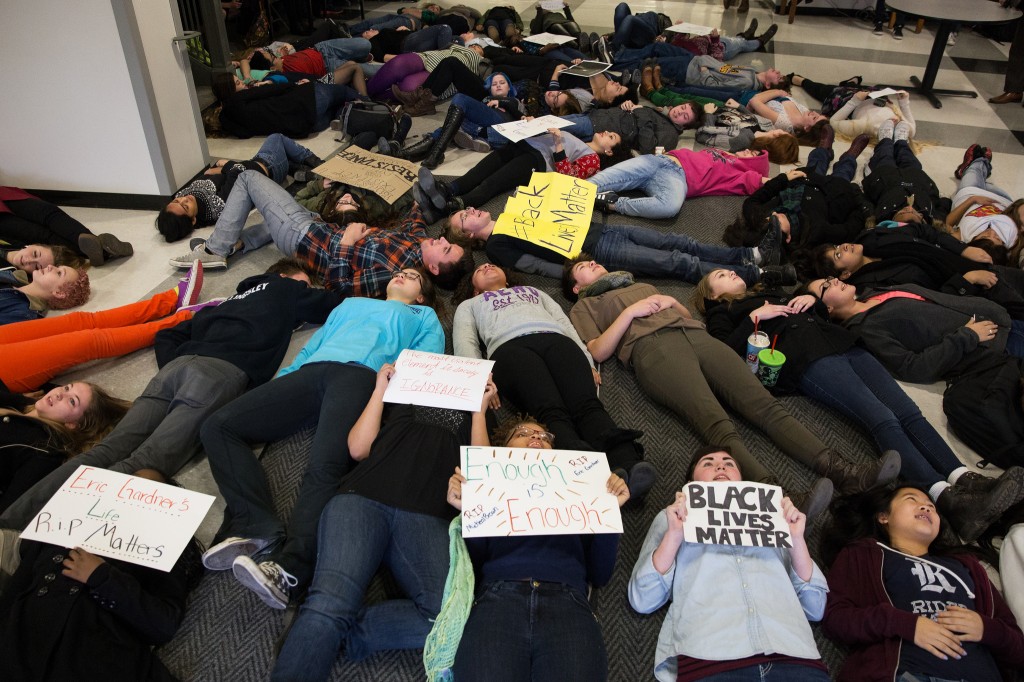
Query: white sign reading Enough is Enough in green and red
xmin=462 ymin=445 xmax=623 ymax=538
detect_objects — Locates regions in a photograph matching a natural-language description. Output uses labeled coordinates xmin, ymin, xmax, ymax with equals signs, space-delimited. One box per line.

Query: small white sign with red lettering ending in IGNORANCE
xmin=384 ymin=348 xmax=495 ymax=412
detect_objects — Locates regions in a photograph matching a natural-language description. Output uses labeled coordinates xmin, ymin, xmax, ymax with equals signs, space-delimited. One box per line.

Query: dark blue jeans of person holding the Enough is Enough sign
xmin=452 ymin=581 xmax=608 ymax=682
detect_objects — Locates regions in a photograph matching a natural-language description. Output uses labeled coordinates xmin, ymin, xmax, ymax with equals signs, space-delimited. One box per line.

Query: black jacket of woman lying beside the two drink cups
xmin=705 ymin=291 xmax=857 ymax=393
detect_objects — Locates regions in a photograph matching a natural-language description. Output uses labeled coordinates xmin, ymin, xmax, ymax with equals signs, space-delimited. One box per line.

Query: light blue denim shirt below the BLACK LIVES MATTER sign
xmin=629 ymin=513 xmax=828 ymax=682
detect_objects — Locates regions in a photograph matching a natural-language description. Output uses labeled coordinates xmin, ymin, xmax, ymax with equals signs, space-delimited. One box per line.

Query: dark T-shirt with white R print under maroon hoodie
xmin=882 ymin=551 xmax=1001 ymax=682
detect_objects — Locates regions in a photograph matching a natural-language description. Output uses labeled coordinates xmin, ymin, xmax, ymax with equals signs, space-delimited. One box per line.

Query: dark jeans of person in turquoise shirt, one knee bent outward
xmin=200 ymin=363 xmax=377 ymax=586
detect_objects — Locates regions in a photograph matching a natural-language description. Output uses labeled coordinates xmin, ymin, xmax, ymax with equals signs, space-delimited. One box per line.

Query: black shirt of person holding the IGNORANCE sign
xmin=339 ymin=404 xmax=472 ymax=519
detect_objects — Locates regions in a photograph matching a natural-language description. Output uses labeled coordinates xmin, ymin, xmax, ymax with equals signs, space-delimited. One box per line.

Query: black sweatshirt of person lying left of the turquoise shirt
xmin=154 ymin=274 xmax=341 ymax=387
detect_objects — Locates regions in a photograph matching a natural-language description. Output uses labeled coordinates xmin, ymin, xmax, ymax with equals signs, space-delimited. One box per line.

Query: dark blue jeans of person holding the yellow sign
xmin=593 ymin=225 xmax=761 ymax=286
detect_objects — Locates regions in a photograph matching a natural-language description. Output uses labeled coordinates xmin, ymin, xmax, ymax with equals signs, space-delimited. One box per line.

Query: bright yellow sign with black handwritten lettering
xmin=493 ymin=173 xmax=597 ymax=258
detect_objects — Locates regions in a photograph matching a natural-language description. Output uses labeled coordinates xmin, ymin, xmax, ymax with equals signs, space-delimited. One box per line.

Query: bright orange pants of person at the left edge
xmin=0 ymin=288 xmax=193 ymax=392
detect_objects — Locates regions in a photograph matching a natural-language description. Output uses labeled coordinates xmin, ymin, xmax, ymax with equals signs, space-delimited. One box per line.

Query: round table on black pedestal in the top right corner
xmin=886 ymin=0 xmax=1021 ymax=109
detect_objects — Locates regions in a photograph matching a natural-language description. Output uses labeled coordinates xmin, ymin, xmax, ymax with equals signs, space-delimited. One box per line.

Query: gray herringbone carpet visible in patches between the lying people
xmin=149 ymin=188 xmax=874 ymax=682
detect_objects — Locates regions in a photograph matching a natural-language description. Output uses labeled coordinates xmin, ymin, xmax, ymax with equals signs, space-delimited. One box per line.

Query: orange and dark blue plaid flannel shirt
xmin=296 ymin=206 xmax=427 ymax=298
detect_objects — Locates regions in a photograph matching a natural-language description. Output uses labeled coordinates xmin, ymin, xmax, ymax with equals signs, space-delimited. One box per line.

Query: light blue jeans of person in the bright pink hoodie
xmin=590 ymin=154 xmax=686 ymax=218
